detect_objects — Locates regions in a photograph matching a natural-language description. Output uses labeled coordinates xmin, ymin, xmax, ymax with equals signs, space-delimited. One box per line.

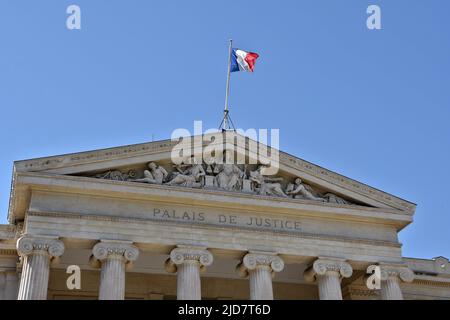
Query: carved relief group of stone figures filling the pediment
xmin=89 ymin=157 xmax=353 ymax=204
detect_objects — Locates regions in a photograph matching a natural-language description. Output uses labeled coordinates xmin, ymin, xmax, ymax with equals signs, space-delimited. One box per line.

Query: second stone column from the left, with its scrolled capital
xmin=91 ymin=240 xmax=139 ymax=300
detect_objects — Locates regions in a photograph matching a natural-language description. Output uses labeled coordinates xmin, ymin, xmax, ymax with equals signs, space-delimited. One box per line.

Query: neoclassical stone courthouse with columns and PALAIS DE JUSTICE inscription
xmin=0 ymin=133 xmax=450 ymax=299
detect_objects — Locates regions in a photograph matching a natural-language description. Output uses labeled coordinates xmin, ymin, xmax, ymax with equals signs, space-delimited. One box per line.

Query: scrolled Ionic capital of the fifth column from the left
xmin=304 ymin=258 xmax=353 ymax=282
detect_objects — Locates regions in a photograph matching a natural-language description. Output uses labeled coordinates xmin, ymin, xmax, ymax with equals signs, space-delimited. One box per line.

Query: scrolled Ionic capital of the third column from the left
xmin=166 ymin=246 xmax=213 ymax=273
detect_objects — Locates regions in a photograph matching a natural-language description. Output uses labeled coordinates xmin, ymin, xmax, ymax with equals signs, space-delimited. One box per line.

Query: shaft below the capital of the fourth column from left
xmin=248 ymin=266 xmax=273 ymax=300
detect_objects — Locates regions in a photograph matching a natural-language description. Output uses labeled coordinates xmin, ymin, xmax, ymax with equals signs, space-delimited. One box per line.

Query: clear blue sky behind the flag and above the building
xmin=0 ymin=0 xmax=450 ymax=258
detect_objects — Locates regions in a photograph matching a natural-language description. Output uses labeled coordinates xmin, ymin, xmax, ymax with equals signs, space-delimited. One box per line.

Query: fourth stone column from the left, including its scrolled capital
xmin=237 ymin=252 xmax=284 ymax=300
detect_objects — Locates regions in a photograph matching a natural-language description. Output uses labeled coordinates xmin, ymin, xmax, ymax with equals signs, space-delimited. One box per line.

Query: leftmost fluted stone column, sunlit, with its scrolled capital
xmin=17 ymin=235 xmax=64 ymax=300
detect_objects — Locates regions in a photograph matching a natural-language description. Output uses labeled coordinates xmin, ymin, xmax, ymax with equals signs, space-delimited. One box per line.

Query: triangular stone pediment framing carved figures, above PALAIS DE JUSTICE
xmin=10 ymin=133 xmax=415 ymax=214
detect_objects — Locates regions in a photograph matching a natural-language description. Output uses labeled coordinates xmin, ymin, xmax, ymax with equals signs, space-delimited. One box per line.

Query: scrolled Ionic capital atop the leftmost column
xmin=16 ymin=235 xmax=65 ymax=258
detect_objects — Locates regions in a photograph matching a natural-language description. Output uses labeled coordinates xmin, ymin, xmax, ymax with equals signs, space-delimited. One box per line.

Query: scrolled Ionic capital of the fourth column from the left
xmin=237 ymin=252 xmax=284 ymax=277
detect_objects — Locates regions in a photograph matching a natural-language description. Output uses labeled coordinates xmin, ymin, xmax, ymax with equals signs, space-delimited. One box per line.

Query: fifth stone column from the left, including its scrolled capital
xmin=304 ymin=258 xmax=353 ymax=300
